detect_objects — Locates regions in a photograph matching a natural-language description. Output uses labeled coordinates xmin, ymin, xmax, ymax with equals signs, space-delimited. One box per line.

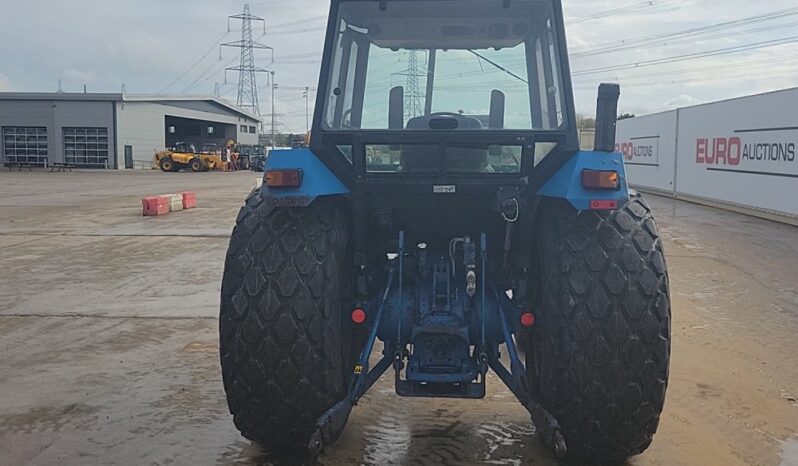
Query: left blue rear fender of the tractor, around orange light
xmin=261 ymin=149 xmax=349 ymax=207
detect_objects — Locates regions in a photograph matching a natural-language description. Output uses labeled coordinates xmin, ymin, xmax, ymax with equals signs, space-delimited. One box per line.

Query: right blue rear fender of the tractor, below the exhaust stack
xmin=538 ymin=151 xmax=629 ymax=210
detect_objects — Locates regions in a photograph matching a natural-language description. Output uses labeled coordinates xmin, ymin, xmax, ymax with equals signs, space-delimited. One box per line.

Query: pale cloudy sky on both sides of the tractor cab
xmin=0 ymin=0 xmax=798 ymax=132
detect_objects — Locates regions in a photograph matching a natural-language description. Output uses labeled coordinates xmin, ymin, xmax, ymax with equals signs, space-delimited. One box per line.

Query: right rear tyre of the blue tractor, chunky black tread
xmin=527 ymin=193 xmax=671 ymax=461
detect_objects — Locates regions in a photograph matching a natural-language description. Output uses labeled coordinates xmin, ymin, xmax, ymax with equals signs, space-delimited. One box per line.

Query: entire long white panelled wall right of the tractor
xmin=618 ymin=89 xmax=798 ymax=218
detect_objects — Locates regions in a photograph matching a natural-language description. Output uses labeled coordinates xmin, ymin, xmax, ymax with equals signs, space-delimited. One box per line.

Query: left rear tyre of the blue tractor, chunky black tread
xmin=219 ymin=190 xmax=352 ymax=450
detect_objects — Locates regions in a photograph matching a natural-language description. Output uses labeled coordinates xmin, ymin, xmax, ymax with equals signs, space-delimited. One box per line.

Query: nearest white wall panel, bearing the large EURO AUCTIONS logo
xmin=677 ymin=90 xmax=798 ymax=215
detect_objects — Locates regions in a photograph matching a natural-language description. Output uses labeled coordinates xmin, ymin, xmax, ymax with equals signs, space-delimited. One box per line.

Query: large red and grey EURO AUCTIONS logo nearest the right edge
xmin=695 ymin=127 xmax=798 ymax=178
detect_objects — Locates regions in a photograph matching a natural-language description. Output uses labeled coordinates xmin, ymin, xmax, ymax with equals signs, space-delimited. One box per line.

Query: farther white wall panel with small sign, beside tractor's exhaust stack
xmin=616 ymin=110 xmax=676 ymax=193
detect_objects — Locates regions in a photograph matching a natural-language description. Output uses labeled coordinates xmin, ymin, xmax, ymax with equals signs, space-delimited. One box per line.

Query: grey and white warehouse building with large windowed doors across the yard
xmin=0 ymin=92 xmax=260 ymax=169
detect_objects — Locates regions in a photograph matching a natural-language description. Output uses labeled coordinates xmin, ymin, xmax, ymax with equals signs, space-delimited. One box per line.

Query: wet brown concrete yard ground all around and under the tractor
xmin=0 ymin=172 xmax=798 ymax=466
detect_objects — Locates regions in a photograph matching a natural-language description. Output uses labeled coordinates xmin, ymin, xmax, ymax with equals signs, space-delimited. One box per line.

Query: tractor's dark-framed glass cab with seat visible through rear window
xmin=311 ymin=0 xmax=578 ymax=186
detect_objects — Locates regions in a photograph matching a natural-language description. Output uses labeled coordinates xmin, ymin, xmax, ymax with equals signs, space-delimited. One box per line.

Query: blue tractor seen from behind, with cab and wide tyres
xmin=220 ymin=0 xmax=671 ymax=460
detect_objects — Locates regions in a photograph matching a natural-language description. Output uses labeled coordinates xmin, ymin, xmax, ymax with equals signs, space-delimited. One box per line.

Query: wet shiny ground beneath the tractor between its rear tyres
xmin=319 ymin=364 xmax=554 ymax=465
